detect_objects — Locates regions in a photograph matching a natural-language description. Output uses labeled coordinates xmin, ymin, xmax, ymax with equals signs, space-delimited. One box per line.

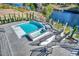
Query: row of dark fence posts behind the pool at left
xmin=0 ymin=12 xmax=35 ymax=25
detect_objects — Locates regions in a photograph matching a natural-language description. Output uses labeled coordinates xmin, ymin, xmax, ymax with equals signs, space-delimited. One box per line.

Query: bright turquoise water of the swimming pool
xmin=19 ymin=21 xmax=43 ymax=34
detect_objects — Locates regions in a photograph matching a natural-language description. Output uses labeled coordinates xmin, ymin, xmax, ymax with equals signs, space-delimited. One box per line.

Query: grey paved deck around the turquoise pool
xmin=0 ymin=21 xmax=70 ymax=56
